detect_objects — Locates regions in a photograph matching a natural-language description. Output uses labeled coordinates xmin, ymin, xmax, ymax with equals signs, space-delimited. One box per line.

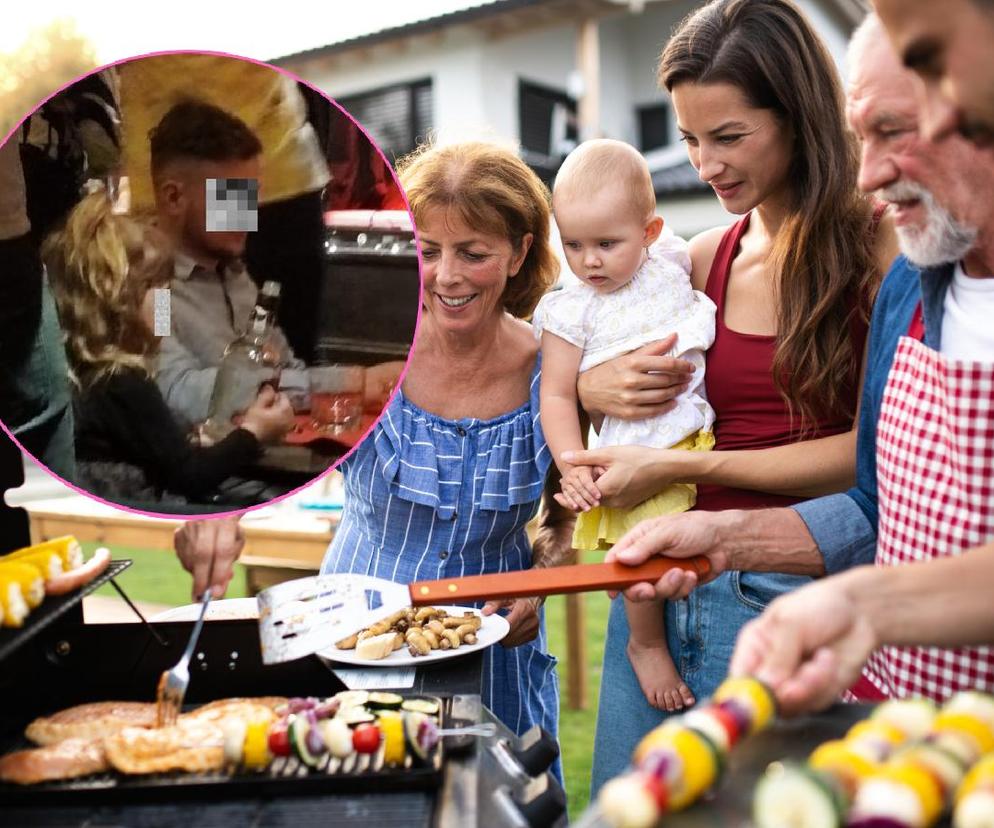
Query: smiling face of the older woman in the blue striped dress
xmin=418 ymin=207 xmax=531 ymax=334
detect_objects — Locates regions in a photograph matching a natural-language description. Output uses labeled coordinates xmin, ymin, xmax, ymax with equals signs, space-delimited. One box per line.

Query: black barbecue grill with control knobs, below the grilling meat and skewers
xmin=0 ymin=562 xmax=566 ymax=828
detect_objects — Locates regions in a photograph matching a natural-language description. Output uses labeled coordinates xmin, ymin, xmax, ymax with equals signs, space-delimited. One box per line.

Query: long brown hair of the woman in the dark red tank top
xmin=658 ymin=0 xmax=878 ymax=430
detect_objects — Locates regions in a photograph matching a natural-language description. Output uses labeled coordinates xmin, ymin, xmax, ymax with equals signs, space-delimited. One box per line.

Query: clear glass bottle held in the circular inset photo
xmin=203 ymin=281 xmax=282 ymax=441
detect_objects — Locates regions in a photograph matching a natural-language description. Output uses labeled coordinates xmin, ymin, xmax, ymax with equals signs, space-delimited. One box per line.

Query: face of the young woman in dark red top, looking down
xmin=671 ymin=82 xmax=793 ymax=215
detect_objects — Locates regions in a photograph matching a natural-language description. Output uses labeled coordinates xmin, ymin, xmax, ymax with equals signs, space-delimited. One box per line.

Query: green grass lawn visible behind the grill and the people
xmin=89 ymin=543 xmax=609 ymax=817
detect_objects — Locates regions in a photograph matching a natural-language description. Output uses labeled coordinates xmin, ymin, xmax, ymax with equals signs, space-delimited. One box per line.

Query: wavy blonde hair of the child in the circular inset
xmin=43 ymin=192 xmax=172 ymax=388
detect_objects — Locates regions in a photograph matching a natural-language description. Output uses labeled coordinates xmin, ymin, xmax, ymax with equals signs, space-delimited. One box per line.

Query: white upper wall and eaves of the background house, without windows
xmin=295 ymin=0 xmax=846 ymax=149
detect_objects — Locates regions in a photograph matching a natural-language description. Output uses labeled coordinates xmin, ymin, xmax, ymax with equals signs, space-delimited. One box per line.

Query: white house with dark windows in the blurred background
xmin=273 ymin=0 xmax=868 ymax=237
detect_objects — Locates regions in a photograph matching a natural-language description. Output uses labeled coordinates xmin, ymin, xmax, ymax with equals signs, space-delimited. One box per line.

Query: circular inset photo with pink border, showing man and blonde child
xmin=0 ymin=52 xmax=421 ymax=515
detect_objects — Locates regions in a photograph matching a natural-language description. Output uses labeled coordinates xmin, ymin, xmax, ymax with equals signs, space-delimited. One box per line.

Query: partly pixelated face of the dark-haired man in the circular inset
xmin=183 ymin=158 xmax=262 ymax=259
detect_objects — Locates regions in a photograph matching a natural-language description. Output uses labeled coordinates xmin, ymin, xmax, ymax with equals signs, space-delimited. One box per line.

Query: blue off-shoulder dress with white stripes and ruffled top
xmin=321 ymin=360 xmax=559 ymax=770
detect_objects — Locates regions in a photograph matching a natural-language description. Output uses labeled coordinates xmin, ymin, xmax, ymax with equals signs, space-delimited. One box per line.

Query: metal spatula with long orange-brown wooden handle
xmin=258 ymin=557 xmax=711 ymax=664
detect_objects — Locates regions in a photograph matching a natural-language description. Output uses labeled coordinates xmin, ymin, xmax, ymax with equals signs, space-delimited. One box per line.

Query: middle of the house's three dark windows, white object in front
xmin=518 ymin=80 xmax=579 ymax=183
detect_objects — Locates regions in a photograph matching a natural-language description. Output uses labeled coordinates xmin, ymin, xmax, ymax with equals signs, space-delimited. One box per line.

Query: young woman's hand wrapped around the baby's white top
xmin=576 ymin=334 xmax=694 ymax=420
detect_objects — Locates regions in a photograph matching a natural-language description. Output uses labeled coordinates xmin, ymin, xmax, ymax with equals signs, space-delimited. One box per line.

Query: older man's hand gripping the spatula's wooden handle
xmin=605 ymin=512 xmax=728 ymax=601
